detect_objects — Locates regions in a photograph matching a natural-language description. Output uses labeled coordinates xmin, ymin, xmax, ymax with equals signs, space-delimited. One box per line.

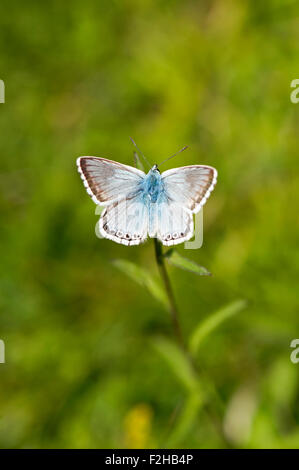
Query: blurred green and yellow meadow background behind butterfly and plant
xmin=0 ymin=0 xmax=299 ymax=448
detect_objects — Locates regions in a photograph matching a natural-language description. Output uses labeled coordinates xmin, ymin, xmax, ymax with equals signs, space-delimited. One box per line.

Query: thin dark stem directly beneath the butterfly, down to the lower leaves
xmin=154 ymin=238 xmax=186 ymax=350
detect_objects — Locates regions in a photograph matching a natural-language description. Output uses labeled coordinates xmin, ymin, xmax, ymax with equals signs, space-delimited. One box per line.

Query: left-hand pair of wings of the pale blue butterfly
xmin=77 ymin=157 xmax=148 ymax=245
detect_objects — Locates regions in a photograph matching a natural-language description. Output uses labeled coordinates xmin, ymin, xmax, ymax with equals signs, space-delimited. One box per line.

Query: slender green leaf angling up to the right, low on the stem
xmin=190 ymin=300 xmax=247 ymax=354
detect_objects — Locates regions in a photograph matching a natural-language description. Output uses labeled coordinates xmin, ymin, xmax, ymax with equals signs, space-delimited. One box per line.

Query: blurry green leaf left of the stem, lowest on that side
xmin=153 ymin=338 xmax=199 ymax=393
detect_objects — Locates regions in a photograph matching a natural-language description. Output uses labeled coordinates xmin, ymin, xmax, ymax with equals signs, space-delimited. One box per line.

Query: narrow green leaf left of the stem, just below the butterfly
xmin=112 ymin=259 xmax=168 ymax=308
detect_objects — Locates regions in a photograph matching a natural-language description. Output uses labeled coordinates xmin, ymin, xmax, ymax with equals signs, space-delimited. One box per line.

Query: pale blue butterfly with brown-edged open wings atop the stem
xmin=77 ymin=153 xmax=217 ymax=246
